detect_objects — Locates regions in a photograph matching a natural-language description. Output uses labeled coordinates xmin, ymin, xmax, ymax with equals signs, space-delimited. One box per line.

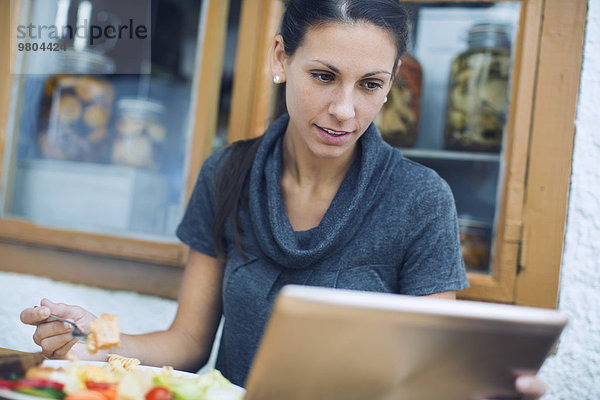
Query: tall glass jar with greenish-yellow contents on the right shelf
xmin=445 ymin=23 xmax=510 ymax=152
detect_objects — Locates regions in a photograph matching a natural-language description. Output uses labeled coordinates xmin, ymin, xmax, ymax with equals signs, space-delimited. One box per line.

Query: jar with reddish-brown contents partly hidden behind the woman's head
xmin=376 ymin=53 xmax=423 ymax=147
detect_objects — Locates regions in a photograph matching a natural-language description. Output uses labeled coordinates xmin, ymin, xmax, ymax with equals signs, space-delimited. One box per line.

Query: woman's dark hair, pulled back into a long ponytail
xmin=212 ymin=0 xmax=408 ymax=257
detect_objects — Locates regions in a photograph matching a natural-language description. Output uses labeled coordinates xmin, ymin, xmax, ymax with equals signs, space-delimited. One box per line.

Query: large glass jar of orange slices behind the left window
xmin=37 ymin=50 xmax=114 ymax=162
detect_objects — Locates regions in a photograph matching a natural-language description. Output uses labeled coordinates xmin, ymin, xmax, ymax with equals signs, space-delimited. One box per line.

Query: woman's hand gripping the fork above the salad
xmin=21 ymin=299 xmax=96 ymax=360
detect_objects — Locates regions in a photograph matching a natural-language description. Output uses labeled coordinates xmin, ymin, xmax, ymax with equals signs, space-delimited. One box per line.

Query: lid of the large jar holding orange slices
xmin=57 ymin=49 xmax=115 ymax=74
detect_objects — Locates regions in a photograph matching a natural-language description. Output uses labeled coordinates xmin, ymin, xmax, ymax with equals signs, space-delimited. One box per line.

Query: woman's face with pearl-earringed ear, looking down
xmin=272 ymin=23 xmax=396 ymax=158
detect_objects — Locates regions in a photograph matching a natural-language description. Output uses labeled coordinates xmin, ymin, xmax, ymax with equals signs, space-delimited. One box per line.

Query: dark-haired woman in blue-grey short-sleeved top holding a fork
xmin=21 ymin=0 xmax=540 ymax=396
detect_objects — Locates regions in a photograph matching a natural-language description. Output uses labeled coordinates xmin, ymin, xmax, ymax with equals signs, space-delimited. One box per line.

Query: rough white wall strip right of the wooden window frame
xmin=541 ymin=0 xmax=600 ymax=400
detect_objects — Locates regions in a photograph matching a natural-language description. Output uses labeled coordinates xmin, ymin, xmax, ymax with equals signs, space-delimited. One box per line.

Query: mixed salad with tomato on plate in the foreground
xmin=0 ymin=356 xmax=245 ymax=400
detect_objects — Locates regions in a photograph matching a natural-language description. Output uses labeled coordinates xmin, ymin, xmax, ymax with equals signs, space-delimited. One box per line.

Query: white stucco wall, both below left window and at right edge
xmin=0 ymin=0 xmax=600 ymax=400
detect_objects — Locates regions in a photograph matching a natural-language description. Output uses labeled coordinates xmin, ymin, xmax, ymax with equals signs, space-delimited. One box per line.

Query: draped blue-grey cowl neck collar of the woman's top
xmin=249 ymin=115 xmax=399 ymax=269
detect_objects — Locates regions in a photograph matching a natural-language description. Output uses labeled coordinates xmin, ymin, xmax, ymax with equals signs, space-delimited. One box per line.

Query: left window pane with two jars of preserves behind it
xmin=2 ymin=0 xmax=209 ymax=242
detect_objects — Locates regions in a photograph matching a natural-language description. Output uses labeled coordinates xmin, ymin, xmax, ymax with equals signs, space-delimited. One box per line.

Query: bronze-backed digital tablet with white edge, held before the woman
xmin=245 ymin=286 xmax=567 ymax=400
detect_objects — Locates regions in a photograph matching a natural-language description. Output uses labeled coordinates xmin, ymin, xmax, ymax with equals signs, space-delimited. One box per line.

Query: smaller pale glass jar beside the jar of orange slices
xmin=112 ymin=97 xmax=166 ymax=170
